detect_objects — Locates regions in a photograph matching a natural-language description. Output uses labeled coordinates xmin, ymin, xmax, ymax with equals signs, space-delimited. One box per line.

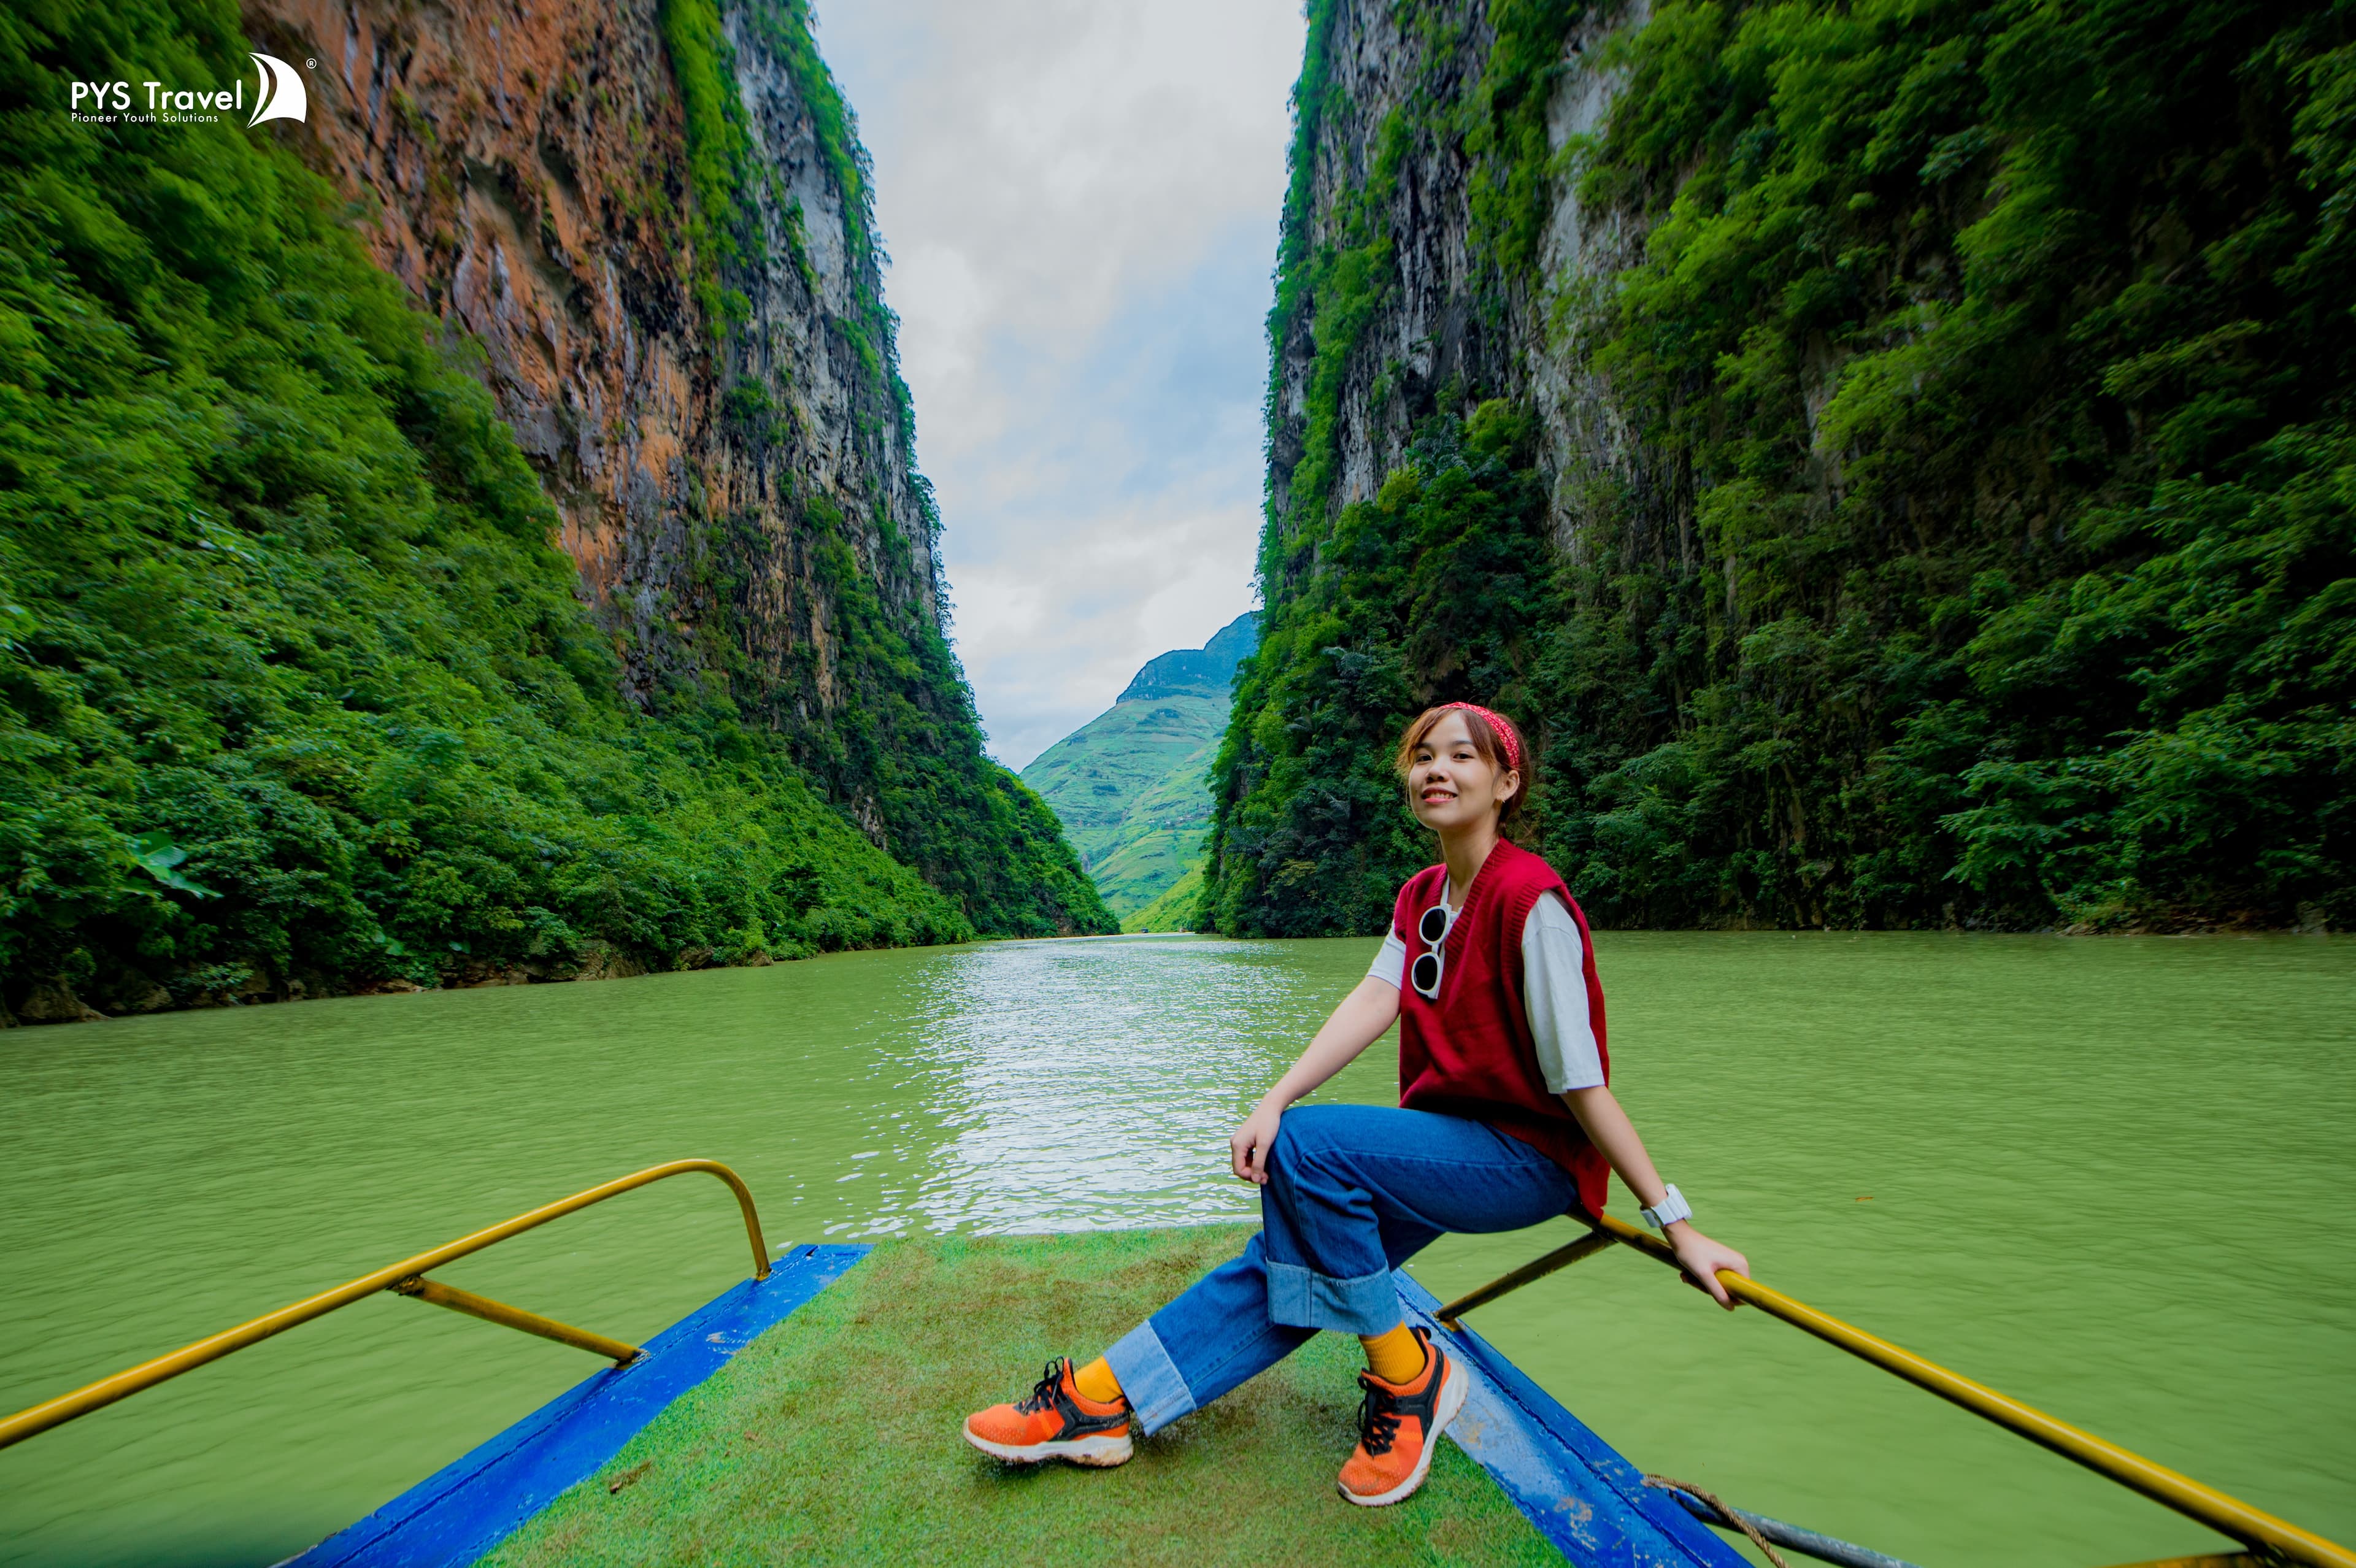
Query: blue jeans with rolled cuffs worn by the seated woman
xmin=1105 ymin=1104 xmax=1579 ymax=1431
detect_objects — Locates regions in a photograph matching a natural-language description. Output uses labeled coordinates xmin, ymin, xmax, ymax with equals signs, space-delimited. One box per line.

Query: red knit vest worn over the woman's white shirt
xmin=1390 ymin=838 xmax=1612 ymax=1215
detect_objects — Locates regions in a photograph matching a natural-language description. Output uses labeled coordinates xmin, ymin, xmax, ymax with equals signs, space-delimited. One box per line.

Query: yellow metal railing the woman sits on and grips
xmin=1433 ymin=1215 xmax=2356 ymax=1568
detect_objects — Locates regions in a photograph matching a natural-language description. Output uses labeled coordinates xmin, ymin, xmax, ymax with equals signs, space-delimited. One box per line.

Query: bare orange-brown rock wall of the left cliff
xmin=245 ymin=0 xmax=688 ymax=664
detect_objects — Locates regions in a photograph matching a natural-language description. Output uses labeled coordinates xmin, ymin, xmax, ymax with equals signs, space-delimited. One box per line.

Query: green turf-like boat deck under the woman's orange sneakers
xmin=483 ymin=1227 xmax=1562 ymax=1568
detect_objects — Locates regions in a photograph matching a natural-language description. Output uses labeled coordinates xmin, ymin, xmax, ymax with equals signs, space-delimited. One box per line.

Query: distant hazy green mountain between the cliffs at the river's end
xmin=1023 ymin=615 xmax=1258 ymax=921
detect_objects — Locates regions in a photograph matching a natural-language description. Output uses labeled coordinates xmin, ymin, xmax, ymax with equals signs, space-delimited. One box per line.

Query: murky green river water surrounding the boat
xmin=0 ymin=932 xmax=2356 ymax=1568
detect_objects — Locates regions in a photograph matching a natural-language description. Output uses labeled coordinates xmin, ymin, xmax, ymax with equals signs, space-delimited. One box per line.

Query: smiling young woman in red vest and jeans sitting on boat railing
xmin=966 ymin=702 xmax=1750 ymax=1504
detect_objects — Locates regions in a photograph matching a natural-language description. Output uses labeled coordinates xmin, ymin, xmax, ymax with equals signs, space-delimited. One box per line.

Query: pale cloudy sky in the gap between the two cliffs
xmin=817 ymin=0 xmax=1303 ymax=767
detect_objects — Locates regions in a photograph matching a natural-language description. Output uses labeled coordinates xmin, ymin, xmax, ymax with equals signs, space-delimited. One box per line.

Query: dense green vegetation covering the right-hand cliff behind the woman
xmin=1206 ymin=0 xmax=2356 ymax=932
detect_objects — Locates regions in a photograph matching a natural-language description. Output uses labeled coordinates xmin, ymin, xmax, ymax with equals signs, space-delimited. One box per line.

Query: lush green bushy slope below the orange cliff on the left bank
xmin=0 ymin=0 xmax=1093 ymax=1017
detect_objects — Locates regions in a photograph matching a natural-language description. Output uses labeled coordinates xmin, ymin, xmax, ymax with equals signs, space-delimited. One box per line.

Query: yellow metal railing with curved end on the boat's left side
xmin=0 ymin=1161 xmax=768 ymax=1448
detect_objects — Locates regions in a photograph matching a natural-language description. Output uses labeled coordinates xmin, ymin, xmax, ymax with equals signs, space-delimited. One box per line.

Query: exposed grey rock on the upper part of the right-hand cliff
xmin=1268 ymin=0 xmax=1649 ymax=544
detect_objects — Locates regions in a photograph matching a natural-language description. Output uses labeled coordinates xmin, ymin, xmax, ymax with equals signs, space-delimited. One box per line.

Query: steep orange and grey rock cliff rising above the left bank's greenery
xmin=232 ymin=0 xmax=1100 ymax=930
